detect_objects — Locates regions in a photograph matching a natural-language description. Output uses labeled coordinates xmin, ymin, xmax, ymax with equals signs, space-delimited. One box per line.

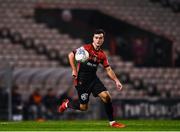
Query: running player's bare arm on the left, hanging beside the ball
xmin=68 ymin=52 xmax=77 ymax=78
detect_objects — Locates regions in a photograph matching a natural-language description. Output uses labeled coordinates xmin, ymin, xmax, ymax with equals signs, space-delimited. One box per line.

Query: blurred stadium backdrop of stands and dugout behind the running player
xmin=0 ymin=0 xmax=180 ymax=121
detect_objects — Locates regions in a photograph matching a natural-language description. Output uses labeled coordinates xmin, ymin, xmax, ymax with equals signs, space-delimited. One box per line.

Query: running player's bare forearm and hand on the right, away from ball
xmin=105 ymin=66 xmax=122 ymax=90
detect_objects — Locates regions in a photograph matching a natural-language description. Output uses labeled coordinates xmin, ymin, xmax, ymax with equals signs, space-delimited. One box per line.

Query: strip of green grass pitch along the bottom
xmin=0 ymin=120 xmax=180 ymax=131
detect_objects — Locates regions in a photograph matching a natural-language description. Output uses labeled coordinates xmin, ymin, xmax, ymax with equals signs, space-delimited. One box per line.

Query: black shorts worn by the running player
xmin=76 ymin=77 xmax=107 ymax=104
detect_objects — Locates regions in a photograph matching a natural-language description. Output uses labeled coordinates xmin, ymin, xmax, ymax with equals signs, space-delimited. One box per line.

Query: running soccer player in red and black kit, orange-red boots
xmin=58 ymin=29 xmax=125 ymax=128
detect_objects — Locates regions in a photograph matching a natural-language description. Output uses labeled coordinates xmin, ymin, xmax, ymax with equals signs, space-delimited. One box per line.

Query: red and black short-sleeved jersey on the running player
xmin=74 ymin=44 xmax=109 ymax=78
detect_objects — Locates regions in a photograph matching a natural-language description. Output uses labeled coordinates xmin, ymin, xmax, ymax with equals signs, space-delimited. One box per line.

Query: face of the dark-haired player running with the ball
xmin=93 ymin=33 xmax=104 ymax=47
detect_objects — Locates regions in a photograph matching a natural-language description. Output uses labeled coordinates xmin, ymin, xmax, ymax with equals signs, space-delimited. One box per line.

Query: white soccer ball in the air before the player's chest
xmin=75 ymin=47 xmax=89 ymax=62
